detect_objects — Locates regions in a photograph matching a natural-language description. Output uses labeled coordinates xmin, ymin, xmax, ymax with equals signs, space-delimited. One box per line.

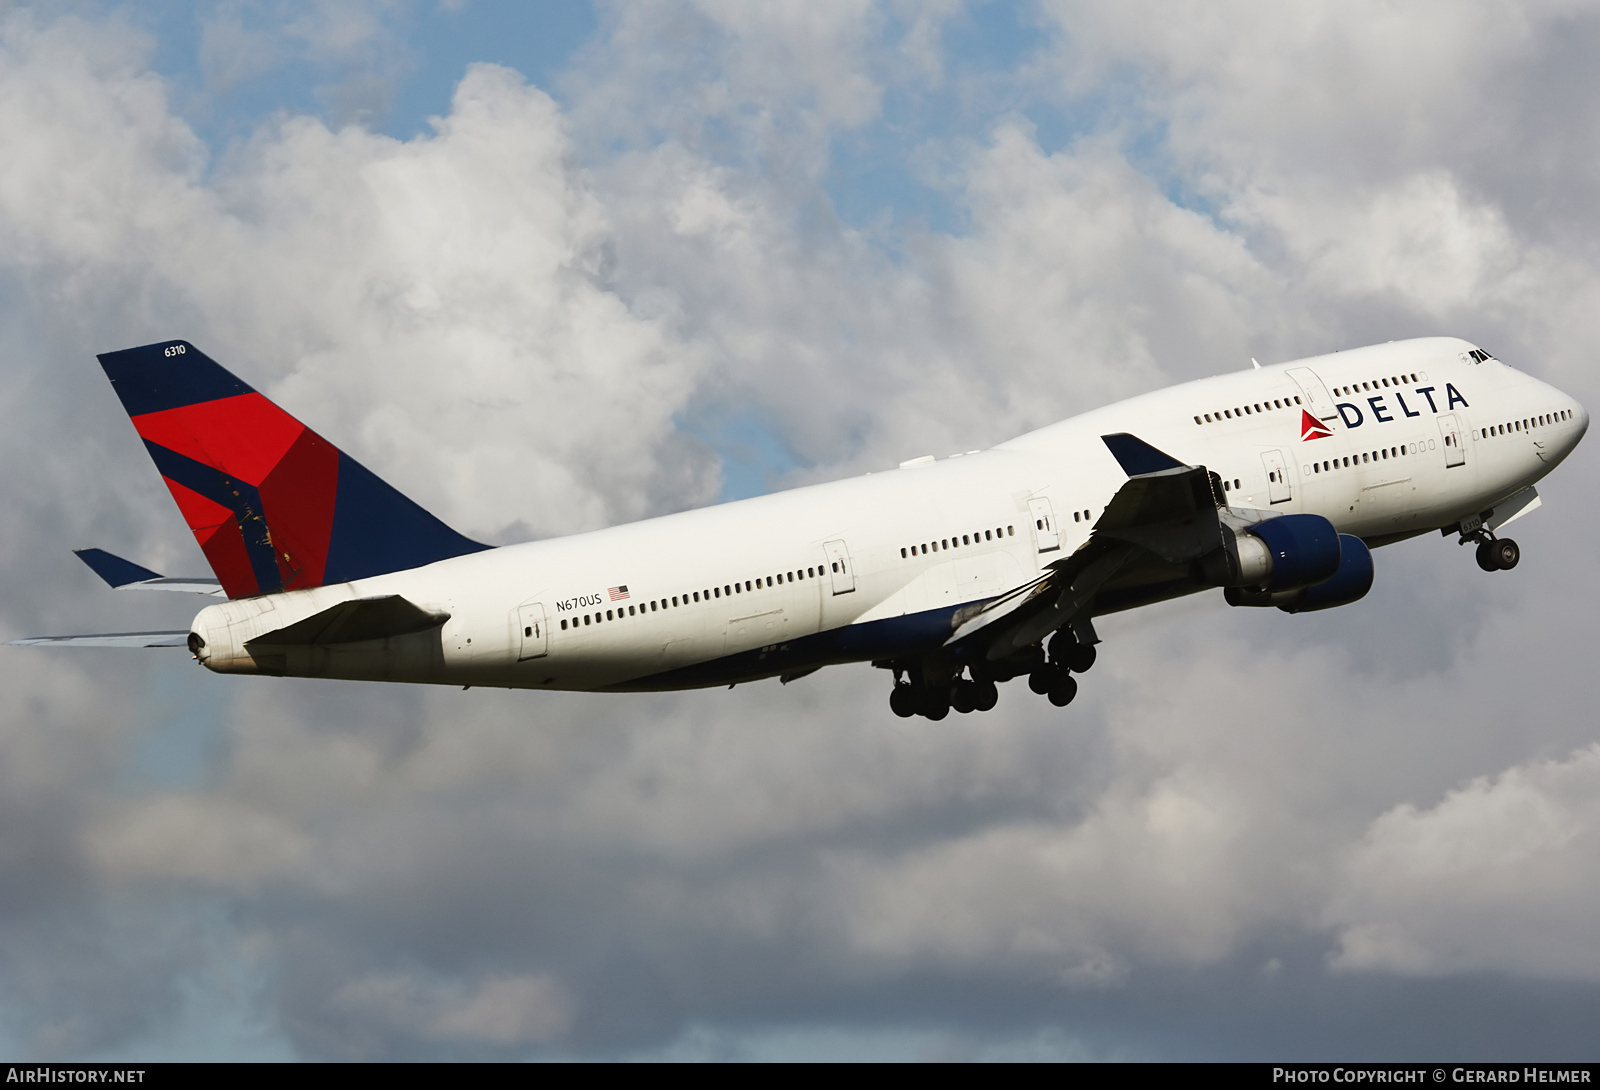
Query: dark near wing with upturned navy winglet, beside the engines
xmin=946 ymin=432 xmax=1222 ymax=659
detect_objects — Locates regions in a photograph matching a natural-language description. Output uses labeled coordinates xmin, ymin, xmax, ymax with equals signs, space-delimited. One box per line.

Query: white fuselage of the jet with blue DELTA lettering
xmin=194 ymin=338 xmax=1589 ymax=690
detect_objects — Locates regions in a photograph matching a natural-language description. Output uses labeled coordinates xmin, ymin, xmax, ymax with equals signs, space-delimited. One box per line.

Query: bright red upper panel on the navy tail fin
xmin=133 ymin=392 xmax=306 ymax=487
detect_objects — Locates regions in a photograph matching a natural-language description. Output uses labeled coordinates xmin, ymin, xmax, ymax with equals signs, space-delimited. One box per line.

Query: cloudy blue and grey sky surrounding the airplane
xmin=0 ymin=0 xmax=1600 ymax=1060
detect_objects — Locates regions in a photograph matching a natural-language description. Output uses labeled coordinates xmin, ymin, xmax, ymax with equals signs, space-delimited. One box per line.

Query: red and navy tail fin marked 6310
xmin=99 ymin=341 xmax=488 ymax=599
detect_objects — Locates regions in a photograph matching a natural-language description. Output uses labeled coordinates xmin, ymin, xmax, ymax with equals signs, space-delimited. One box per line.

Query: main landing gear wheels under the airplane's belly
xmin=882 ymin=629 xmax=1094 ymax=720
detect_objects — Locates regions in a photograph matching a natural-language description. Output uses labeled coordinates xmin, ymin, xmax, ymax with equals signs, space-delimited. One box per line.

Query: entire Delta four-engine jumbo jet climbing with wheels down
xmin=11 ymin=338 xmax=1589 ymax=720
